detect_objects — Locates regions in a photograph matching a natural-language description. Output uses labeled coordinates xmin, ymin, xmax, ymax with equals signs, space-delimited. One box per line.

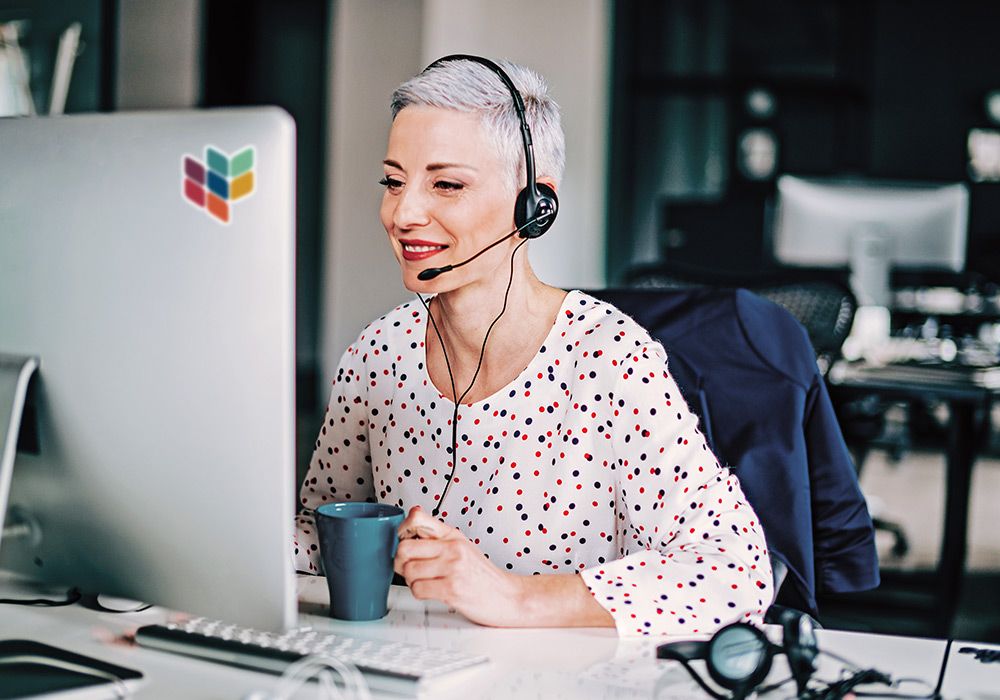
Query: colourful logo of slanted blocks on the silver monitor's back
xmin=181 ymin=146 xmax=256 ymax=224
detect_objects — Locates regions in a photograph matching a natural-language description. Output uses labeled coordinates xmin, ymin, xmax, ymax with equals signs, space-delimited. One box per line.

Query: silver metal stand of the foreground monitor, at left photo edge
xmin=0 ymin=353 xmax=38 ymax=543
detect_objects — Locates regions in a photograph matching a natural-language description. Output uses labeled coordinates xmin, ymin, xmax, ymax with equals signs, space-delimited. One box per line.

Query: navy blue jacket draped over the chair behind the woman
xmin=589 ymin=288 xmax=879 ymax=614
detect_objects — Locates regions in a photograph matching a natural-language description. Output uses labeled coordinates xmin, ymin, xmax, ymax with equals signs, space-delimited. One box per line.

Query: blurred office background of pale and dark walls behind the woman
xmin=0 ymin=0 xmax=1000 ymax=641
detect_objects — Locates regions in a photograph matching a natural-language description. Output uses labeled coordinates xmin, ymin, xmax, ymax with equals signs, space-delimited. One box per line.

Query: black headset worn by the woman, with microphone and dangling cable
xmin=408 ymin=54 xmax=559 ymax=517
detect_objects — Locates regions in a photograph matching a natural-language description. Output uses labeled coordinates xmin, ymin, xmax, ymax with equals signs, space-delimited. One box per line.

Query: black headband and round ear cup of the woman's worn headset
xmin=422 ymin=53 xmax=559 ymax=238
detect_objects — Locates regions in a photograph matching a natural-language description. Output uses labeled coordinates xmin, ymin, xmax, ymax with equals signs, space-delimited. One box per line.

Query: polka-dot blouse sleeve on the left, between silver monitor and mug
xmin=294 ymin=343 xmax=375 ymax=574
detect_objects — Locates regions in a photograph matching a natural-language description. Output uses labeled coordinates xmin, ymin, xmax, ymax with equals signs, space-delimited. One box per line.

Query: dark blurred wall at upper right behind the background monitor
xmin=608 ymin=0 xmax=1000 ymax=281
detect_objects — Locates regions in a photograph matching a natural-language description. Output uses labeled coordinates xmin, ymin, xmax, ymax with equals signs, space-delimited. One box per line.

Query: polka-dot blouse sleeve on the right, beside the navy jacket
xmin=581 ymin=342 xmax=773 ymax=635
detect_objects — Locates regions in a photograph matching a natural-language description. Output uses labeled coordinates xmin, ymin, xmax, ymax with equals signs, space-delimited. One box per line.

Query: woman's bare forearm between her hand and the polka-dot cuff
xmin=517 ymin=574 xmax=615 ymax=627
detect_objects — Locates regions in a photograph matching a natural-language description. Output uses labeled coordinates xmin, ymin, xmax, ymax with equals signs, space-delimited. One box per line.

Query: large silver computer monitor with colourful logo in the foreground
xmin=0 ymin=108 xmax=297 ymax=629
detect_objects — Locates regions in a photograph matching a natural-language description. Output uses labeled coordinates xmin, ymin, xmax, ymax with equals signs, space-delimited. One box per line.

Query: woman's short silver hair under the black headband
xmin=392 ymin=60 xmax=566 ymax=194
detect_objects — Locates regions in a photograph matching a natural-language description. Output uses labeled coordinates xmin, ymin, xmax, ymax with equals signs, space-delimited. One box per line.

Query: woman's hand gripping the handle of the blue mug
xmin=394 ymin=506 xmax=524 ymax=627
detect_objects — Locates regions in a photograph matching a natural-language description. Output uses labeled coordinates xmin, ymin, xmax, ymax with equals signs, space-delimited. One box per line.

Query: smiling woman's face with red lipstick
xmin=380 ymin=105 xmax=520 ymax=292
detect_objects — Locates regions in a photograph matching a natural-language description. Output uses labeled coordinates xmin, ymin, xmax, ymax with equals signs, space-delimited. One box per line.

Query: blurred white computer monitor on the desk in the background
xmin=774 ymin=175 xmax=969 ymax=306
